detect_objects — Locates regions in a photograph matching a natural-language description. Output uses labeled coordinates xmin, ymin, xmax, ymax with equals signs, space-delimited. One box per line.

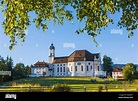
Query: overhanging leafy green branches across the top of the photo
xmin=0 ymin=0 xmax=138 ymax=49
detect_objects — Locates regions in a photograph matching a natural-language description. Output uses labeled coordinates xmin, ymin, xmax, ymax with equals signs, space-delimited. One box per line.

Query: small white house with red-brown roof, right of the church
xmin=112 ymin=66 xmax=123 ymax=80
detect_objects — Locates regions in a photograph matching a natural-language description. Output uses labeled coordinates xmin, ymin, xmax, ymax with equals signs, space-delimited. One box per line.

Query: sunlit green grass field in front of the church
xmin=0 ymin=77 xmax=138 ymax=92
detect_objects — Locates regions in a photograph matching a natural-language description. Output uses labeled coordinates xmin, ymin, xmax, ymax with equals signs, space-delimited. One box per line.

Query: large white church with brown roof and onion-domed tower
xmin=31 ymin=43 xmax=106 ymax=77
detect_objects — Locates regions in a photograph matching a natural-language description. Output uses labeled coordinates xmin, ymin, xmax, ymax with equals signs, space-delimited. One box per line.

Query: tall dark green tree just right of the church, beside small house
xmin=103 ymin=55 xmax=113 ymax=76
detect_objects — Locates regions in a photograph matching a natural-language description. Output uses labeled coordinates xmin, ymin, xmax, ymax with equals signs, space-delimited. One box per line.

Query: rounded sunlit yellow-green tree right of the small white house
xmin=123 ymin=63 xmax=136 ymax=81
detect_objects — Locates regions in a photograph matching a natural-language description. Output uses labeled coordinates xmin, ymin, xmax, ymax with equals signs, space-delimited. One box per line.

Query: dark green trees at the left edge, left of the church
xmin=0 ymin=56 xmax=33 ymax=83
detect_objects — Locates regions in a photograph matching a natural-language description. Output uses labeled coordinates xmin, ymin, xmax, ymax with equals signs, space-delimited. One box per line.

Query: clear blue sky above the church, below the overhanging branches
xmin=0 ymin=7 xmax=138 ymax=65
